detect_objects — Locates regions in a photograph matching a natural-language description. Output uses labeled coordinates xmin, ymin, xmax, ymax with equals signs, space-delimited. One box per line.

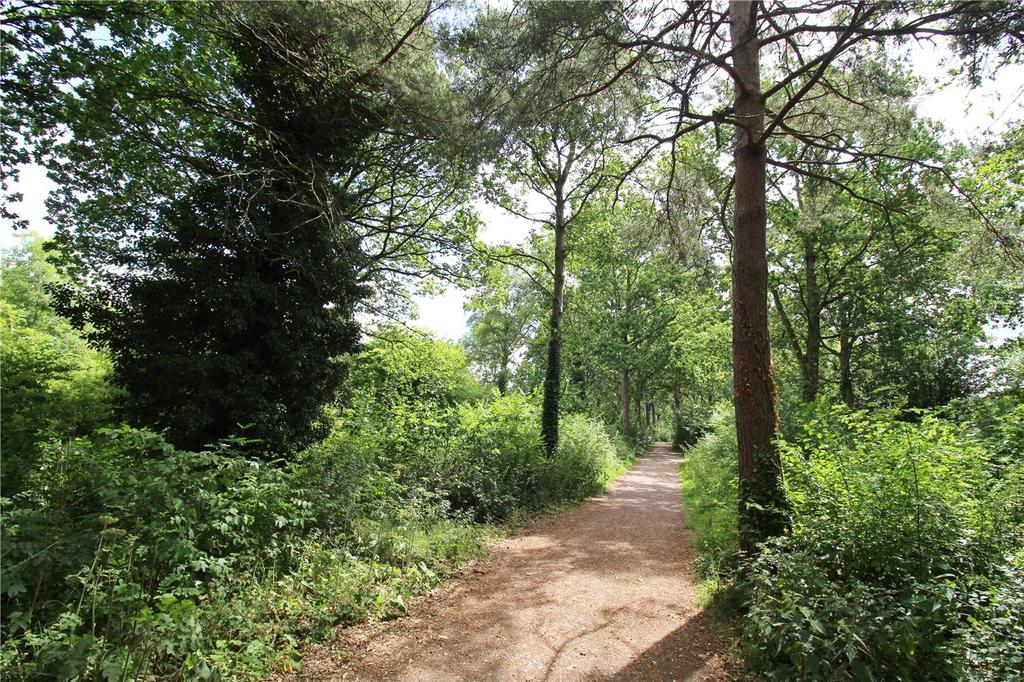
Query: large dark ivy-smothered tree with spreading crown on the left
xmin=5 ymin=2 xmax=473 ymax=452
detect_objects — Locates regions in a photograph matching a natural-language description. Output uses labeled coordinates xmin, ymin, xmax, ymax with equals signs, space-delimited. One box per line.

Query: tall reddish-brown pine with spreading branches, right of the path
xmin=572 ymin=0 xmax=1022 ymax=554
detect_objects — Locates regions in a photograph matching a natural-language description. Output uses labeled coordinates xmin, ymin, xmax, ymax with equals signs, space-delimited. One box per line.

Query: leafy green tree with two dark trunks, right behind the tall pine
xmin=770 ymin=55 xmax=949 ymax=403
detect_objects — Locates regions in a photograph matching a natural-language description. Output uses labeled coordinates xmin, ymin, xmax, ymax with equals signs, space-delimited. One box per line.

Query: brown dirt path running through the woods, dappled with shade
xmin=292 ymin=444 xmax=729 ymax=682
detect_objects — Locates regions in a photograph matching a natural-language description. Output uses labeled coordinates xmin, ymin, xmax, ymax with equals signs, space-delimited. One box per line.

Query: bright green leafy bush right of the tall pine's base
xmin=743 ymin=401 xmax=1024 ymax=680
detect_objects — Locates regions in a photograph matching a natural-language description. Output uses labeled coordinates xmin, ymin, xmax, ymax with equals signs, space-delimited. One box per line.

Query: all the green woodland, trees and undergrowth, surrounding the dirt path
xmin=0 ymin=0 xmax=1024 ymax=680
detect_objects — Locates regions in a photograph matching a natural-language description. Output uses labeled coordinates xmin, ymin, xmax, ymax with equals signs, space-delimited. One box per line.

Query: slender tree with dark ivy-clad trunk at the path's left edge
xmin=467 ymin=3 xmax=637 ymax=455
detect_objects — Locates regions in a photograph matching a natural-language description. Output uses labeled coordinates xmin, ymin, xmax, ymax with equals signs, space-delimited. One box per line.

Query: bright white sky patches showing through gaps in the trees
xmin=0 ymin=43 xmax=1024 ymax=341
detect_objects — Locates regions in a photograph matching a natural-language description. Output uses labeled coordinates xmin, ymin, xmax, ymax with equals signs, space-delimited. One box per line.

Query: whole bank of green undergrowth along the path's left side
xmin=0 ymin=327 xmax=635 ymax=680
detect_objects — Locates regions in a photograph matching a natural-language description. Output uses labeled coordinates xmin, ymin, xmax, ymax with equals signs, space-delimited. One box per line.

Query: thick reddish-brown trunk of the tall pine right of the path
xmin=729 ymin=0 xmax=786 ymax=555
